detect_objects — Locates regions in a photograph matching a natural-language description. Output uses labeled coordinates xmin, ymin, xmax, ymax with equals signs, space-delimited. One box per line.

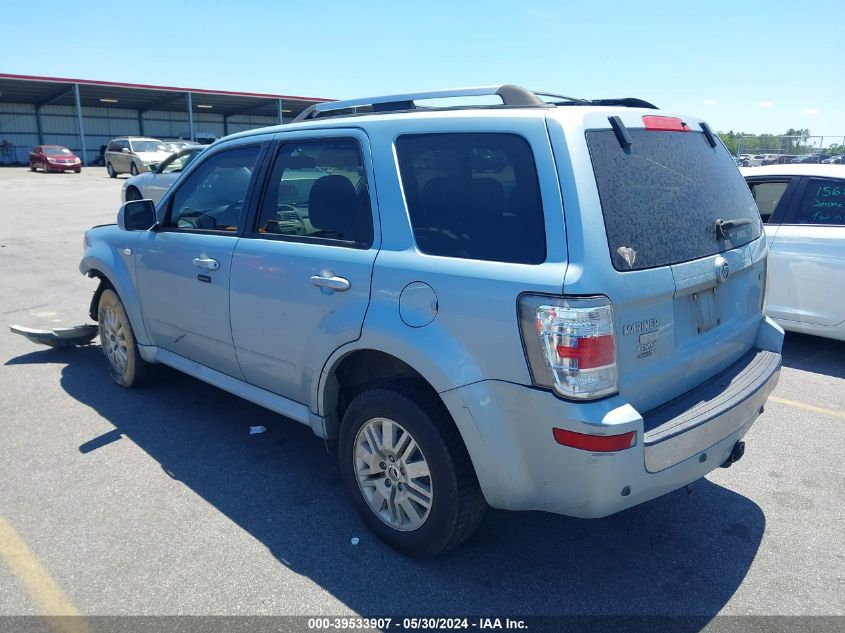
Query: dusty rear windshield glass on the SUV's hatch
xmin=587 ymin=128 xmax=762 ymax=270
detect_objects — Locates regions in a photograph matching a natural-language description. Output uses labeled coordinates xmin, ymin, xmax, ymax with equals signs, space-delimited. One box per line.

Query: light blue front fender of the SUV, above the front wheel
xmin=79 ymin=226 xmax=152 ymax=345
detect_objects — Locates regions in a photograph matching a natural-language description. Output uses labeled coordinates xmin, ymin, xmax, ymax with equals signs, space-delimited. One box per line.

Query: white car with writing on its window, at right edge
xmin=740 ymin=164 xmax=845 ymax=340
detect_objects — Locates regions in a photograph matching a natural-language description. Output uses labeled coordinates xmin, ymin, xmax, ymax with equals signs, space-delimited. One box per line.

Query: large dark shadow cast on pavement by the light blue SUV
xmin=9 ymin=346 xmax=765 ymax=620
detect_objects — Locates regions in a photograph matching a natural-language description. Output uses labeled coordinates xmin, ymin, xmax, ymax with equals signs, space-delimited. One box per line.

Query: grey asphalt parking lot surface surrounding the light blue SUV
xmin=0 ymin=168 xmax=845 ymax=626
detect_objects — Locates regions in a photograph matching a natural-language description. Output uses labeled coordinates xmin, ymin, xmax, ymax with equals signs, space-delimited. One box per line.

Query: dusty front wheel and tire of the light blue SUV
xmin=97 ymin=288 xmax=150 ymax=388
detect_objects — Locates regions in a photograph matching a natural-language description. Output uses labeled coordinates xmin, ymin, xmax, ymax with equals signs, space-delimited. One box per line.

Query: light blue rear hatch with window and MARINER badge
xmin=552 ymin=110 xmax=765 ymax=412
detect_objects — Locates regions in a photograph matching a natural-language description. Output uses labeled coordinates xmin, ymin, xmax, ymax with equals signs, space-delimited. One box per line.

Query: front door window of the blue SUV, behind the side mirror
xmin=165 ymin=145 xmax=260 ymax=232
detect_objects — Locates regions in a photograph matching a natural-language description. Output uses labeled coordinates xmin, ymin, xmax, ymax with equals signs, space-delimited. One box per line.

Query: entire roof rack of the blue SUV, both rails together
xmin=293 ymin=84 xmax=658 ymax=123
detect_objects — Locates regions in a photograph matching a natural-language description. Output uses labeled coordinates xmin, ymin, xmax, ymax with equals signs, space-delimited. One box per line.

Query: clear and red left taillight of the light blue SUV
xmin=519 ymin=295 xmax=617 ymax=400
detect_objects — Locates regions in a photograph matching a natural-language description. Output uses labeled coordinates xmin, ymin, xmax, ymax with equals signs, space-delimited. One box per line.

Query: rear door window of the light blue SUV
xmin=257 ymin=139 xmax=373 ymax=246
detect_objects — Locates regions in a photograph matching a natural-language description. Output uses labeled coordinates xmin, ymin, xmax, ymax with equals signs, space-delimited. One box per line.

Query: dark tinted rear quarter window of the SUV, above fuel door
xmin=396 ymin=133 xmax=546 ymax=264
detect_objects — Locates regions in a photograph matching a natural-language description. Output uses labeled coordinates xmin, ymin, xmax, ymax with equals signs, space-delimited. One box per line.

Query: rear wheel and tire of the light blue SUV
xmin=338 ymin=381 xmax=487 ymax=556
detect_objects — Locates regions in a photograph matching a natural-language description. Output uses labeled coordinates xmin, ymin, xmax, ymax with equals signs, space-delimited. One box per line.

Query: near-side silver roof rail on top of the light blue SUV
xmin=293 ymin=84 xmax=548 ymax=123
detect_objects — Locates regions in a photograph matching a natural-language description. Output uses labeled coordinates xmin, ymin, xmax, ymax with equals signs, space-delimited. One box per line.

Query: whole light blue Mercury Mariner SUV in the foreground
xmin=80 ymin=86 xmax=783 ymax=555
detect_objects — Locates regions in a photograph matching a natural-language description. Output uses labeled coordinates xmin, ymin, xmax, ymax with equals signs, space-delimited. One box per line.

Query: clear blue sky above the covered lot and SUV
xmin=6 ymin=0 xmax=845 ymax=135
